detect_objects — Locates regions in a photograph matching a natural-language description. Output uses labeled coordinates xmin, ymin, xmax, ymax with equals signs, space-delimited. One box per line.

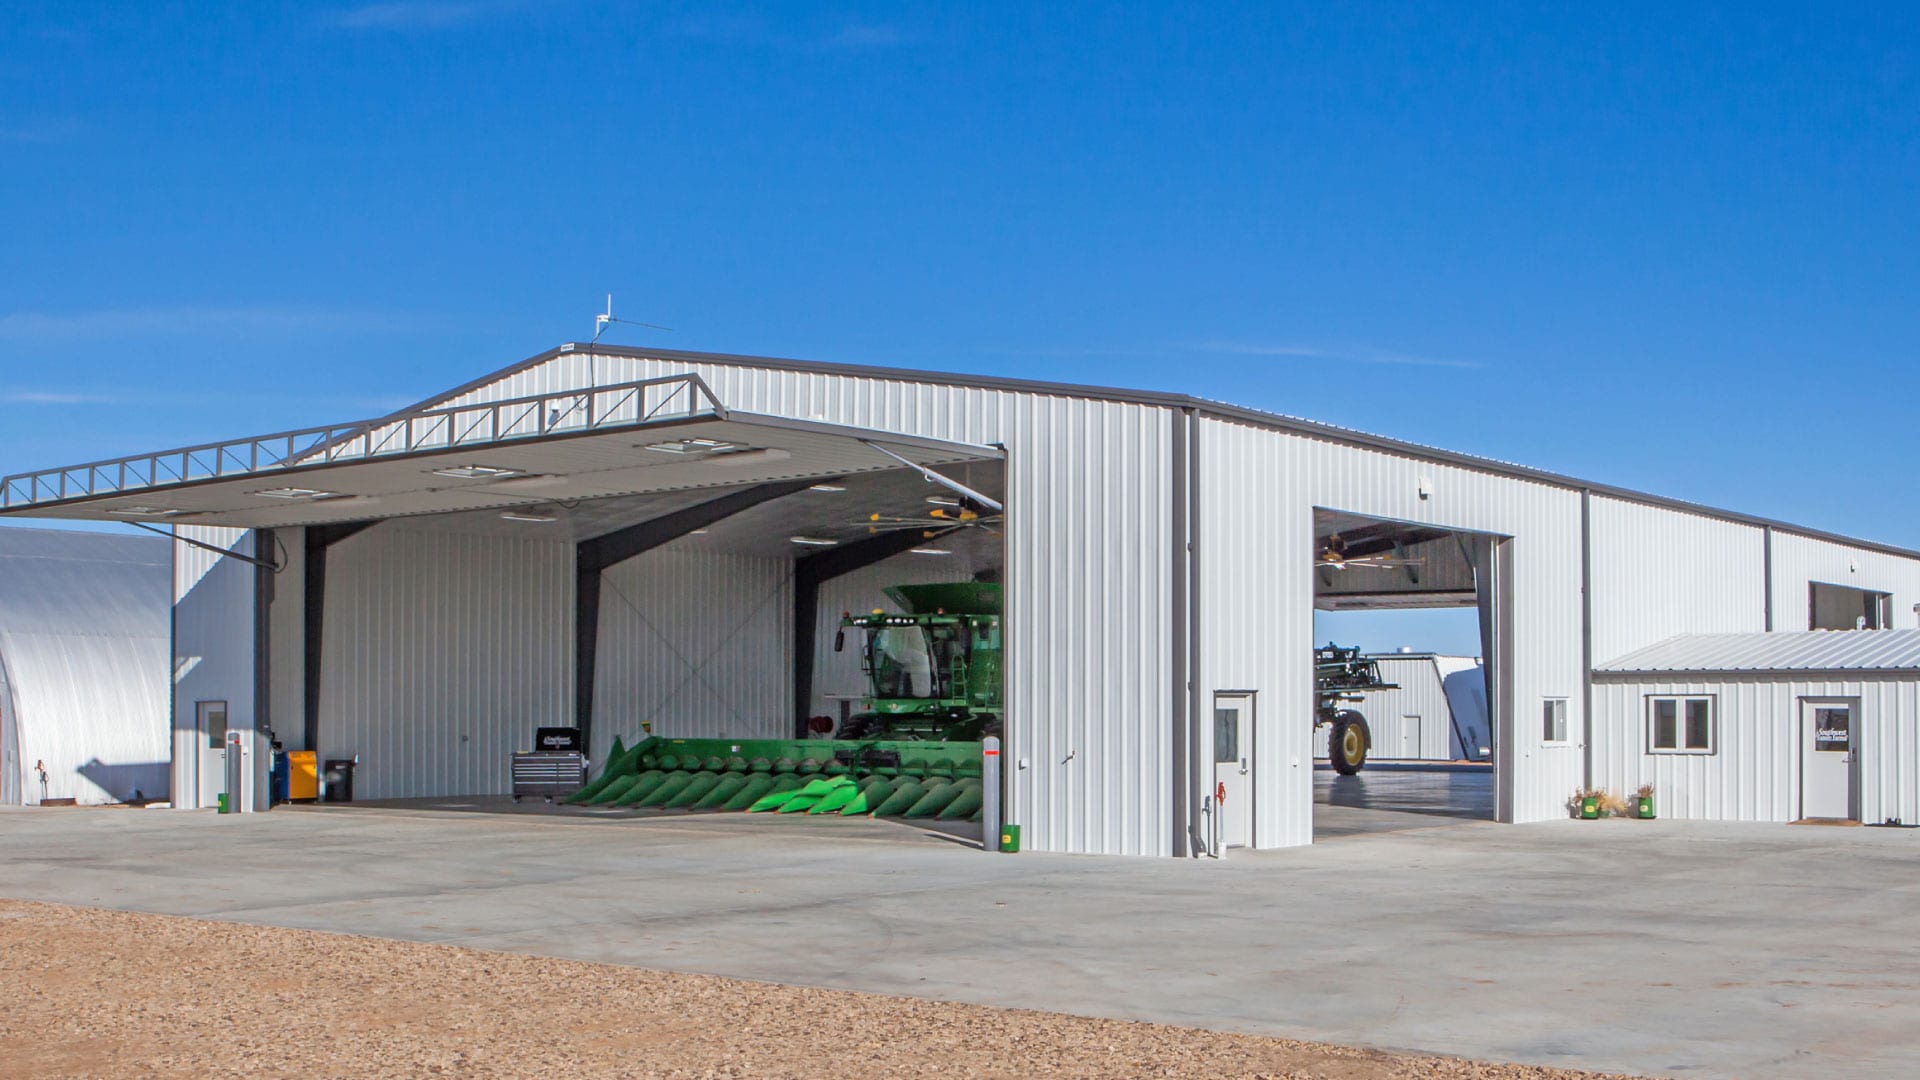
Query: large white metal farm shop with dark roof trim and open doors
xmin=0 ymin=344 xmax=1920 ymax=855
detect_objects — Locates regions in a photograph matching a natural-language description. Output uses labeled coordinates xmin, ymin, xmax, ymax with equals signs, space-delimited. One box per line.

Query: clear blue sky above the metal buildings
xmin=0 ymin=0 xmax=1920 ymax=645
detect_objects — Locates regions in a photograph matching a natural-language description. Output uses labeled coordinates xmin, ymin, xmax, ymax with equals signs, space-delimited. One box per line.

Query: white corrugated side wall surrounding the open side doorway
xmin=1198 ymin=411 xmax=1586 ymax=834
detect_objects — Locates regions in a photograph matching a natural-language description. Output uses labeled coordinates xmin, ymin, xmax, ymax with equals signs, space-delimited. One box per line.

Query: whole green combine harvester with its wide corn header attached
xmin=566 ymin=582 xmax=1004 ymax=821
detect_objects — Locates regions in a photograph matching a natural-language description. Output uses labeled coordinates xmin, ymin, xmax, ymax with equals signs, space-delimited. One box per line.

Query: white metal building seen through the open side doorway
xmin=1313 ymin=651 xmax=1492 ymax=761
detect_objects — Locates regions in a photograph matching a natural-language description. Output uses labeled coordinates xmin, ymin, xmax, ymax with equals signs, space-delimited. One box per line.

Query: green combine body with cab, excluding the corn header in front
xmin=833 ymin=582 xmax=1004 ymax=742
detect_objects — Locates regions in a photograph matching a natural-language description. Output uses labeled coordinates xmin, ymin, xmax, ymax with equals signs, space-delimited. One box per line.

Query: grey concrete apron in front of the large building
xmin=0 ymin=805 xmax=1920 ymax=1078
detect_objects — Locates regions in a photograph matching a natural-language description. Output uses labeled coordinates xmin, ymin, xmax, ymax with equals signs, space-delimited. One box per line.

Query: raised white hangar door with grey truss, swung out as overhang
xmin=0 ymin=375 xmax=1004 ymax=528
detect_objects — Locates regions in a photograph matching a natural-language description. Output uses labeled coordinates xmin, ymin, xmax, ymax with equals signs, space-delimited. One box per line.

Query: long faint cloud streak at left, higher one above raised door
xmin=0 ymin=307 xmax=401 ymax=342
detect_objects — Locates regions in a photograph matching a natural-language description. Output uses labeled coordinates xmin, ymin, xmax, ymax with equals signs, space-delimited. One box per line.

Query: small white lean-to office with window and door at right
xmin=1594 ymin=630 xmax=1920 ymax=824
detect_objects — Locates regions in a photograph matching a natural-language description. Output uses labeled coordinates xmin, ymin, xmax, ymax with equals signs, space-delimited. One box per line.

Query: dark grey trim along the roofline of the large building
xmin=405 ymin=342 xmax=1920 ymax=559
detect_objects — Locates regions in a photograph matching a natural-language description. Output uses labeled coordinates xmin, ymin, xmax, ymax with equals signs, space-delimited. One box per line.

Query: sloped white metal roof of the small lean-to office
xmin=1594 ymin=630 xmax=1920 ymax=675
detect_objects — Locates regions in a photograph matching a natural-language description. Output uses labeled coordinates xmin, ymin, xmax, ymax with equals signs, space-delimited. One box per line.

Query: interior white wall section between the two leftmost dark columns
xmin=319 ymin=521 xmax=574 ymax=799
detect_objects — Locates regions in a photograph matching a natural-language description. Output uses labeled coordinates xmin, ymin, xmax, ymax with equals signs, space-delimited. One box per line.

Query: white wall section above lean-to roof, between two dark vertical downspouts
xmin=1592 ymin=496 xmax=1766 ymax=663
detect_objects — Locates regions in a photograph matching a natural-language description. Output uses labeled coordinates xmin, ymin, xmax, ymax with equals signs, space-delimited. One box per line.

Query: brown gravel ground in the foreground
xmin=0 ymin=901 xmax=1651 ymax=1080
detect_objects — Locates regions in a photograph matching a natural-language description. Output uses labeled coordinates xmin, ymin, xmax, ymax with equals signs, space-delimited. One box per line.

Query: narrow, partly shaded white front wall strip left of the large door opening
xmin=173 ymin=525 xmax=253 ymax=807
